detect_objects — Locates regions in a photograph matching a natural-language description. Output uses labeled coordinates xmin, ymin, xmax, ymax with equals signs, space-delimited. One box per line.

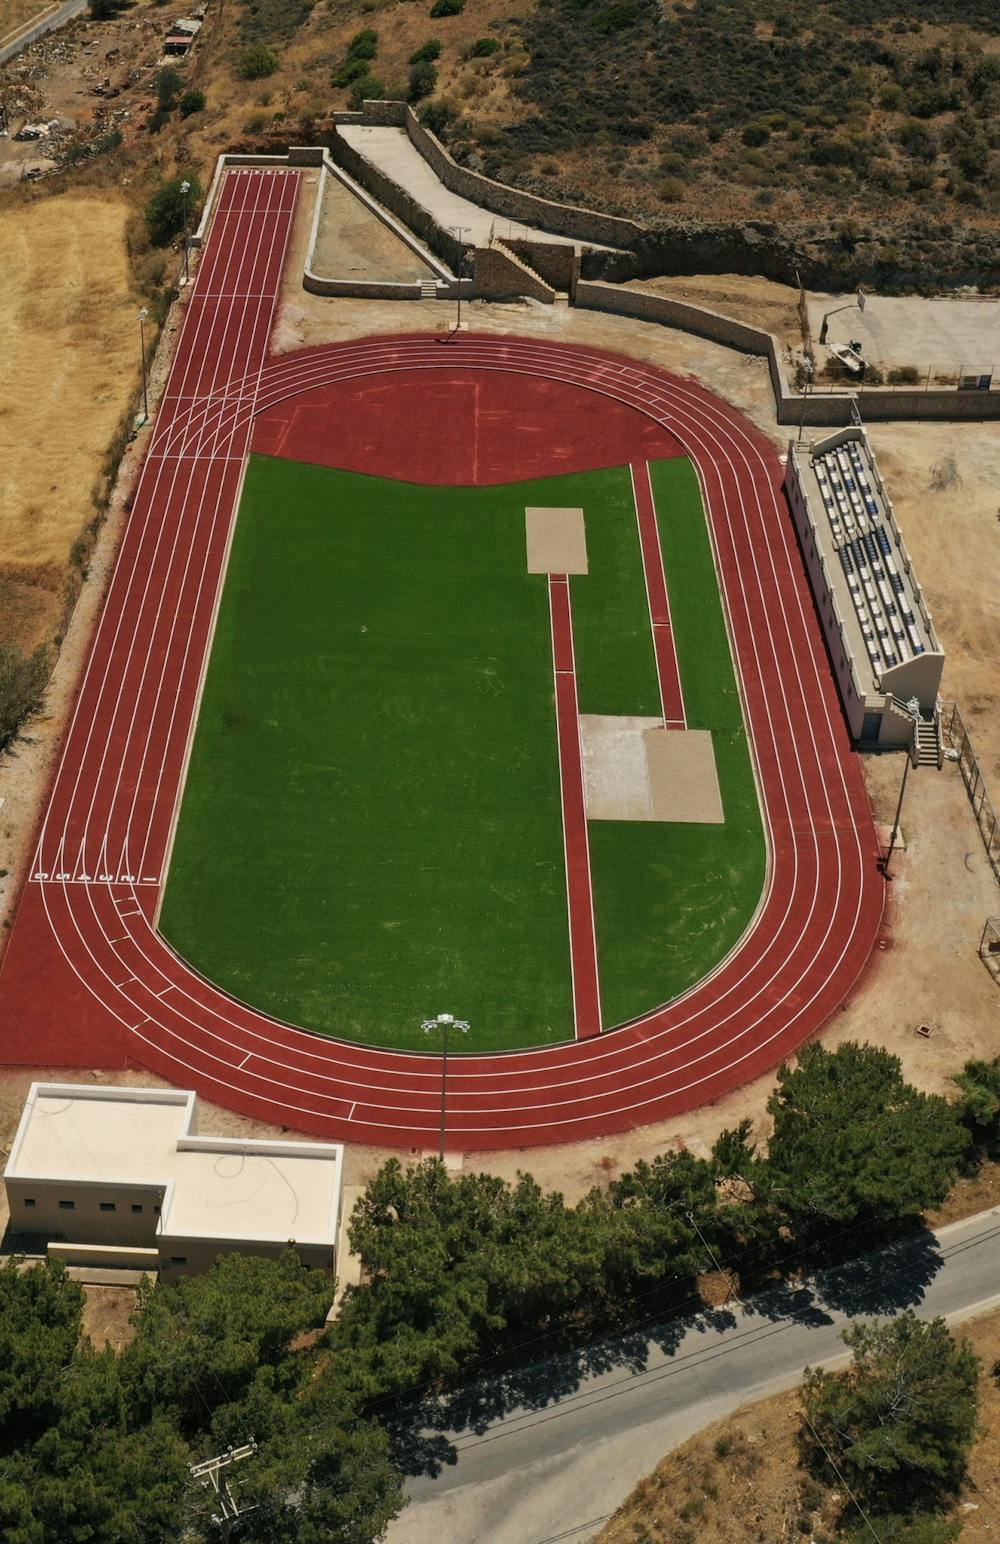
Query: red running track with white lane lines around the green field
xmin=0 ymin=170 xmax=884 ymax=1149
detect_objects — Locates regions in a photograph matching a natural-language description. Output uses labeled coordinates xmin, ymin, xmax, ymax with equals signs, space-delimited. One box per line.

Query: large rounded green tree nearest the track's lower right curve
xmin=765 ymin=1042 xmax=969 ymax=1234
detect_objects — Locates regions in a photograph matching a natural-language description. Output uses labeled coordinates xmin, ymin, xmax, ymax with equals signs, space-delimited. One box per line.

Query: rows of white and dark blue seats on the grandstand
xmin=812 ymin=442 xmax=924 ymax=676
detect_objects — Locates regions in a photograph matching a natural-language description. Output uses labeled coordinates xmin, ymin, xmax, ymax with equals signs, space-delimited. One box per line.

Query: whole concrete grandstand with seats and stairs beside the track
xmin=785 ymin=425 xmax=944 ymax=761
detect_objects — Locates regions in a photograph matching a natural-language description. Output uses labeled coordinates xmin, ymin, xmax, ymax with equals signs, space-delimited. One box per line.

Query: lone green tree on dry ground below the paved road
xmin=802 ymin=1309 xmax=978 ymax=1513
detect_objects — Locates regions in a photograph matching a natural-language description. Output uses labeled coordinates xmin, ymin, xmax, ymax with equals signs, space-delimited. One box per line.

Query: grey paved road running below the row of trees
xmin=387 ymin=1207 xmax=1000 ymax=1544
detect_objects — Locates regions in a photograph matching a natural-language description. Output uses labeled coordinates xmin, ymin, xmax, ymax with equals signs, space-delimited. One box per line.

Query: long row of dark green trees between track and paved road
xmin=0 ymin=1045 xmax=1000 ymax=1544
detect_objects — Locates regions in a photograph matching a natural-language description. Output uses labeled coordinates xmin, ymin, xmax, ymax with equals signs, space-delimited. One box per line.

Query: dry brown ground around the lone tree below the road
xmin=597 ymin=1312 xmax=1000 ymax=1544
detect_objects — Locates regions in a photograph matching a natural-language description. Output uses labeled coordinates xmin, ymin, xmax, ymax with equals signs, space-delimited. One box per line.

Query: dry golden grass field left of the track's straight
xmin=0 ymin=195 xmax=139 ymax=645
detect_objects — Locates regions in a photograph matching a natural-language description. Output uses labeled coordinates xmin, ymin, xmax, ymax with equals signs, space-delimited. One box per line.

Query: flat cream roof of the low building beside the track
xmin=5 ymin=1082 xmax=344 ymax=1246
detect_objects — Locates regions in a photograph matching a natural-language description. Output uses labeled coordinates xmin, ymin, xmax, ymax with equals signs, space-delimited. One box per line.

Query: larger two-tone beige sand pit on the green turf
xmin=580 ymin=713 xmax=725 ymax=826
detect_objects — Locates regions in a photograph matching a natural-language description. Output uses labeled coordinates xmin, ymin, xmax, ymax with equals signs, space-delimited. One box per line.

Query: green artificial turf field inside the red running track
xmin=160 ymin=455 xmax=764 ymax=1050
